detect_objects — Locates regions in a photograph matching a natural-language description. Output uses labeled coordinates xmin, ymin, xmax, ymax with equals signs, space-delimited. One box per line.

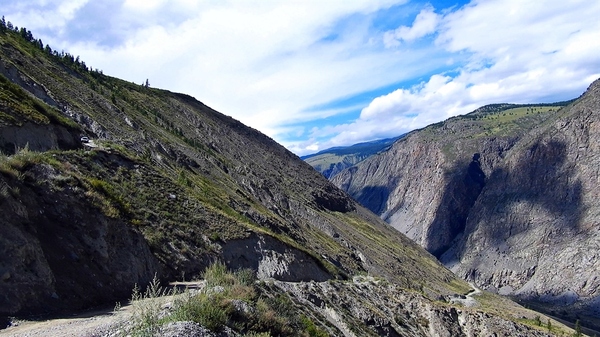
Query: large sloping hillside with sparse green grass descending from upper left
xmin=0 ymin=20 xmax=569 ymax=336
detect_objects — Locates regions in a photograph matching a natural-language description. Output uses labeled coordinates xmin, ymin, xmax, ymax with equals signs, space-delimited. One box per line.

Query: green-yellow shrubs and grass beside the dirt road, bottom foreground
xmin=116 ymin=262 xmax=327 ymax=337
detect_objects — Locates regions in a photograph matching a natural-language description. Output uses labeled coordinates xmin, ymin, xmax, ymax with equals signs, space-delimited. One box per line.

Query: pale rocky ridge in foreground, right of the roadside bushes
xmin=275 ymin=277 xmax=558 ymax=337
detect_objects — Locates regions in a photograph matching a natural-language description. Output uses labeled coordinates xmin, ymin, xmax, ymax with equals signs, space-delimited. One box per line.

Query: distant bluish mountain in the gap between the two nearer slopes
xmin=300 ymin=136 xmax=402 ymax=179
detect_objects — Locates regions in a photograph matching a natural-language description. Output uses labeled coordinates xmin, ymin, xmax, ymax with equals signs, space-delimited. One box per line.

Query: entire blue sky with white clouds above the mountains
xmin=0 ymin=0 xmax=600 ymax=155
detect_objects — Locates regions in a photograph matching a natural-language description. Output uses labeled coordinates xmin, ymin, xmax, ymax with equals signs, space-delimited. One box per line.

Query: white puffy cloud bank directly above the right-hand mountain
xmin=294 ymin=0 xmax=600 ymax=155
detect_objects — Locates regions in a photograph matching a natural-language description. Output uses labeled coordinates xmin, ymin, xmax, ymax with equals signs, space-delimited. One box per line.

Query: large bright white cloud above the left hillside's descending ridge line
xmin=64 ymin=1 xmax=444 ymax=141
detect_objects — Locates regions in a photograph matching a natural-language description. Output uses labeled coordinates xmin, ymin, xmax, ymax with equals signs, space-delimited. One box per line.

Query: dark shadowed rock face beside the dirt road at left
xmin=0 ymin=167 xmax=160 ymax=314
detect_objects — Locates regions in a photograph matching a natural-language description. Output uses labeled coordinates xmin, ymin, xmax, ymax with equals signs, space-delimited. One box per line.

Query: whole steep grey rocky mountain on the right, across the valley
xmin=333 ymin=81 xmax=600 ymax=327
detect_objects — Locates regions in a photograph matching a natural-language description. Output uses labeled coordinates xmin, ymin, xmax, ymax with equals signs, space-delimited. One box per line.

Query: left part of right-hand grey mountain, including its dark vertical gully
xmin=332 ymin=129 xmax=515 ymax=256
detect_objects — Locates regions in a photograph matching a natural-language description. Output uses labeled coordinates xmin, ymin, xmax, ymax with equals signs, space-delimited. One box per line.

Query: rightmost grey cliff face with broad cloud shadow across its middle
xmin=443 ymin=82 xmax=600 ymax=317
